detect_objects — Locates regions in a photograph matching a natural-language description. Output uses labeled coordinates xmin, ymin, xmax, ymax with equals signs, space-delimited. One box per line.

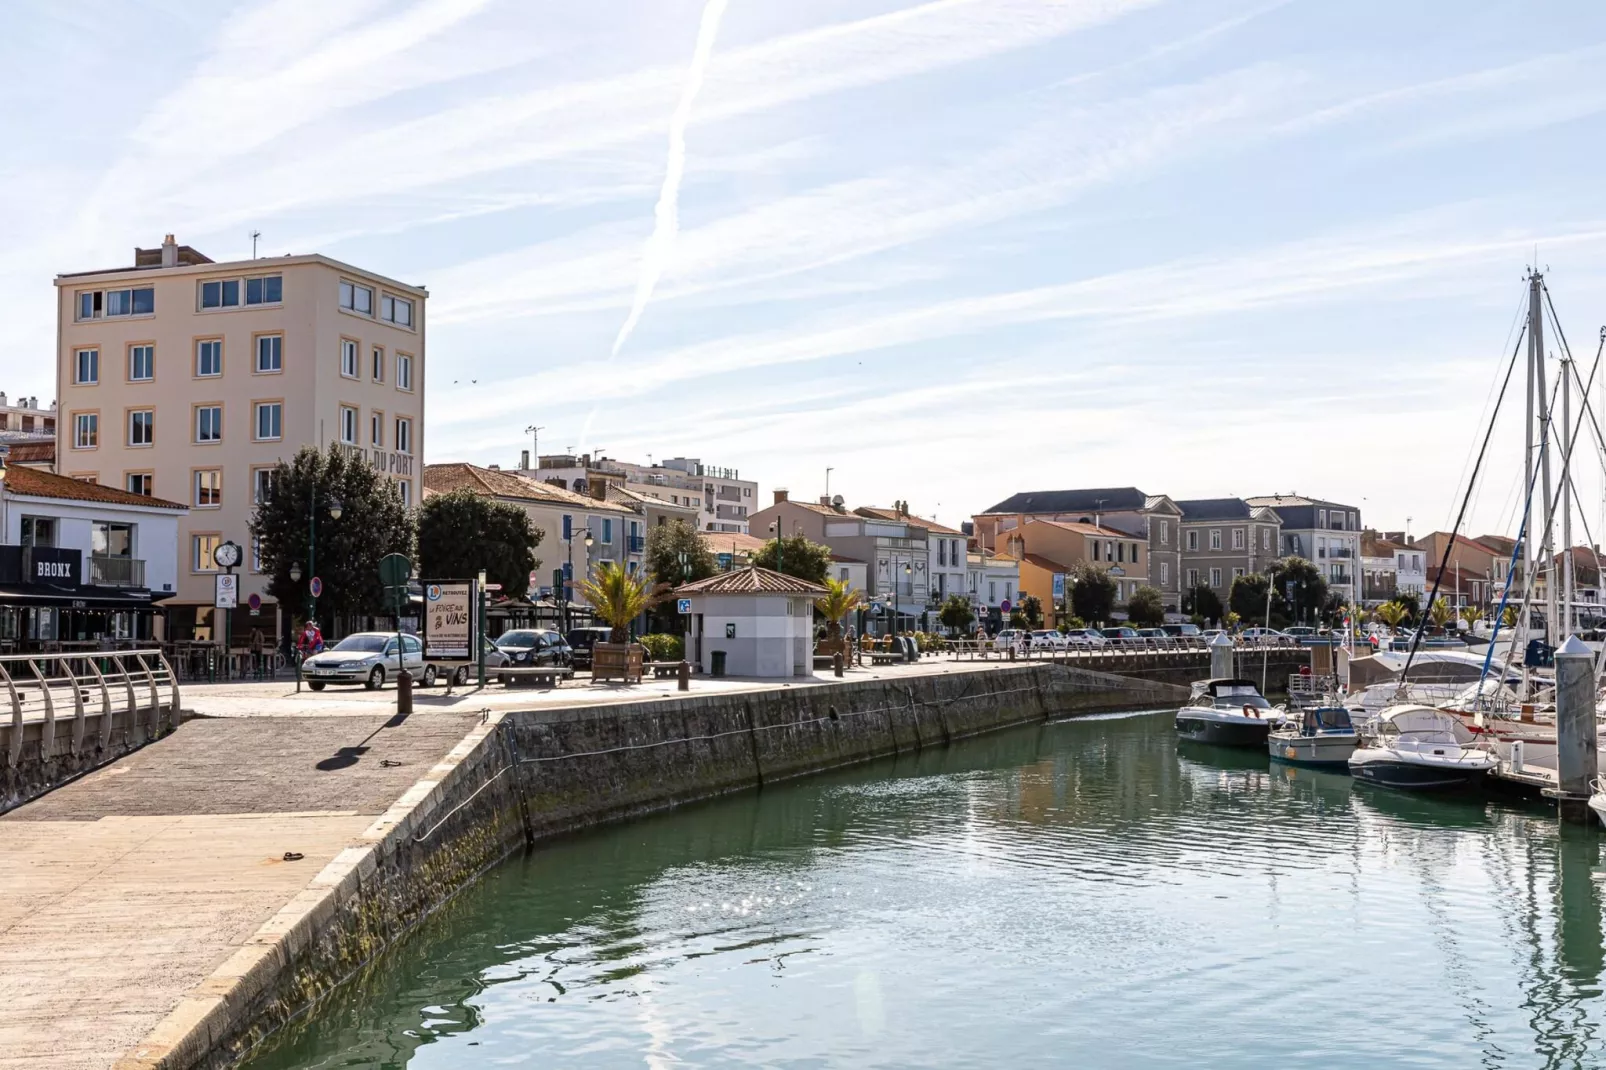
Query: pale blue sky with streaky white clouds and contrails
xmin=0 ymin=0 xmax=1606 ymax=541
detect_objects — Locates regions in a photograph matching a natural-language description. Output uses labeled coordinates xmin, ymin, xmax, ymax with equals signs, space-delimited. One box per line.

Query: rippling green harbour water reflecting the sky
xmin=240 ymin=715 xmax=1606 ymax=1070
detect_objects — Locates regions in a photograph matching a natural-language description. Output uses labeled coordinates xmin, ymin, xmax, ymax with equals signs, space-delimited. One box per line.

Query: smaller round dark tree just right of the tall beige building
xmin=418 ymin=487 xmax=543 ymax=598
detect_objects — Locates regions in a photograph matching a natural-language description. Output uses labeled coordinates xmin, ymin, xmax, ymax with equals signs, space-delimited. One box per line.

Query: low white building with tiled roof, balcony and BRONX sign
xmin=0 ymin=466 xmax=186 ymax=651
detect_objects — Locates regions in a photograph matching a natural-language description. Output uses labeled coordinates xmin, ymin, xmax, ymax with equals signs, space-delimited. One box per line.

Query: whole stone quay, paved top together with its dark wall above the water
xmin=0 ymin=660 xmax=1184 ymax=1070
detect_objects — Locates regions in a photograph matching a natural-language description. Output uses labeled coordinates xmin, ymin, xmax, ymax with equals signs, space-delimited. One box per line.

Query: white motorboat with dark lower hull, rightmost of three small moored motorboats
xmin=1349 ymin=705 xmax=1498 ymax=790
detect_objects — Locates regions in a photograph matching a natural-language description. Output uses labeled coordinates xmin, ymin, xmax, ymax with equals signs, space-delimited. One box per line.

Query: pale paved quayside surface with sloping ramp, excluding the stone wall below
xmin=0 ymin=660 xmax=1162 ymax=1068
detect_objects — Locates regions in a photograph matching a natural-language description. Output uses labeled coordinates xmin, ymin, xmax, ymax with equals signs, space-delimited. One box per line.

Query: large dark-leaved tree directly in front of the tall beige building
xmin=251 ymin=445 xmax=414 ymax=617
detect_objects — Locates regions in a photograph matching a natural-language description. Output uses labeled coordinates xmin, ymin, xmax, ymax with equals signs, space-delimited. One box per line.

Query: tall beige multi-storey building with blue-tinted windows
xmin=56 ymin=235 xmax=429 ymax=638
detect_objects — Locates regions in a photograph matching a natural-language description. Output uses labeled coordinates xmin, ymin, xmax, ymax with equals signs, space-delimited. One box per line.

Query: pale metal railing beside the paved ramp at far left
xmin=0 ymin=649 xmax=180 ymax=766
